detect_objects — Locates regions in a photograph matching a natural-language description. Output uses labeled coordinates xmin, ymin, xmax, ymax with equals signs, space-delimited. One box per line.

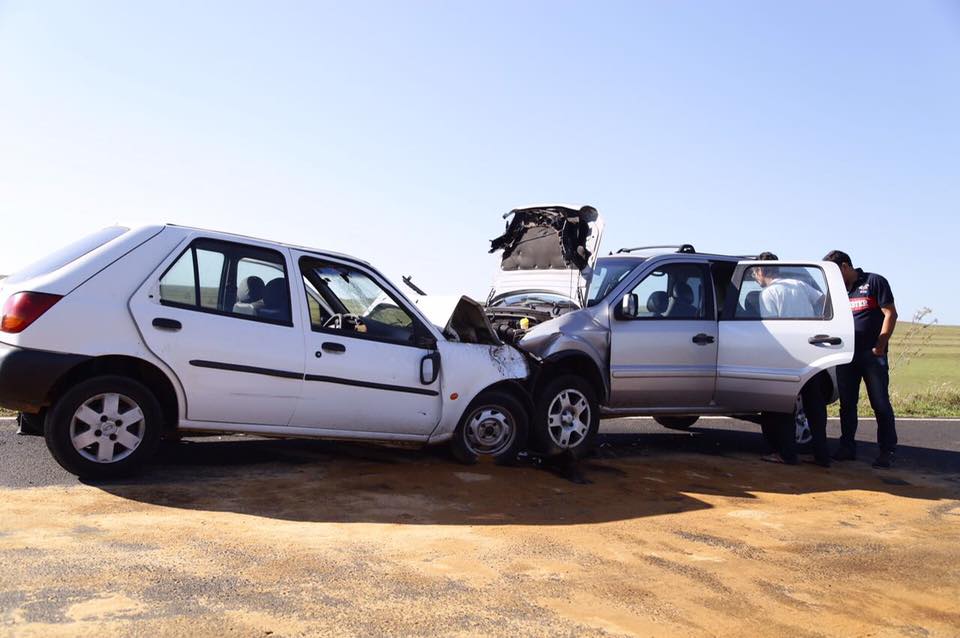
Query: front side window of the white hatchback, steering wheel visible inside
xmin=300 ymin=259 xmax=416 ymax=344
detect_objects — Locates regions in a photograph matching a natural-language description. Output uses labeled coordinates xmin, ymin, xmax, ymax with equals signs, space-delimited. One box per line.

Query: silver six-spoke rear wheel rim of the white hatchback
xmin=70 ymin=392 xmax=145 ymax=463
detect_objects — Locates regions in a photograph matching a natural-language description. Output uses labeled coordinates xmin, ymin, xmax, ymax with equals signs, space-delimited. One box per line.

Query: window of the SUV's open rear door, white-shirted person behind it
xmin=734 ymin=262 xmax=832 ymax=320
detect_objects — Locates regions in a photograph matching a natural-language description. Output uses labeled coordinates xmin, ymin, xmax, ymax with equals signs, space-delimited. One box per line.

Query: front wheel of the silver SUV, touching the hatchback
xmin=533 ymin=374 xmax=600 ymax=459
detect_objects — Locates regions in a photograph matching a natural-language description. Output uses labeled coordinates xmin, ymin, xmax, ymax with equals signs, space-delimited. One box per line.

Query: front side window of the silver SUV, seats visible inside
xmin=630 ymin=264 xmax=713 ymax=319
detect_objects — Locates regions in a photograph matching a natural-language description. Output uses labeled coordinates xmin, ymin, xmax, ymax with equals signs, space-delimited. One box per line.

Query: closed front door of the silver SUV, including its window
xmin=610 ymin=260 xmax=718 ymax=409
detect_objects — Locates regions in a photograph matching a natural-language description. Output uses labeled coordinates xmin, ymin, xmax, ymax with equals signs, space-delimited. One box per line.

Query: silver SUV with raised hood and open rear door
xmin=486 ymin=205 xmax=854 ymax=456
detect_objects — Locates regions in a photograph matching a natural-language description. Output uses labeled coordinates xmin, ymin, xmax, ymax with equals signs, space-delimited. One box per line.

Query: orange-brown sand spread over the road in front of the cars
xmin=0 ymin=448 xmax=960 ymax=637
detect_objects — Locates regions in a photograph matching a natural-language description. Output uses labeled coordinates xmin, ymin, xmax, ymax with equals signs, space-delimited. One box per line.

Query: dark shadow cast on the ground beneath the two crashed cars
xmin=88 ymin=428 xmax=960 ymax=525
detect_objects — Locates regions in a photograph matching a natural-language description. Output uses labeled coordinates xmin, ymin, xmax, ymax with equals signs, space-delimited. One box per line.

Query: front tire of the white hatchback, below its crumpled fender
xmin=450 ymin=390 xmax=529 ymax=465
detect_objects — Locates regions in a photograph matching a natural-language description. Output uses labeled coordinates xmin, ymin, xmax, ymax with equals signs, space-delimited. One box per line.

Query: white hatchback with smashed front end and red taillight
xmin=0 ymin=225 xmax=531 ymax=477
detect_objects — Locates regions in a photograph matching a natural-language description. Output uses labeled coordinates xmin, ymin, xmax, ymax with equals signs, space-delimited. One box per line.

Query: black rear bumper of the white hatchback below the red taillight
xmin=0 ymin=342 xmax=90 ymax=413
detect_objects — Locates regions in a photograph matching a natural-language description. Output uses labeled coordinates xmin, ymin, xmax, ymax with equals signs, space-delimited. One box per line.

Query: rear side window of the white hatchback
xmin=160 ymin=239 xmax=293 ymax=326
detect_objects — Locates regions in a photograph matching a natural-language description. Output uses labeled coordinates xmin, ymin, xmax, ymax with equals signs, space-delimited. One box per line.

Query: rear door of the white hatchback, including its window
xmin=130 ymin=236 xmax=304 ymax=425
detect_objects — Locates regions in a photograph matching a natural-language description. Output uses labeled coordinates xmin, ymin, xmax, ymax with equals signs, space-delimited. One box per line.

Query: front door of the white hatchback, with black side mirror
xmin=292 ymin=253 xmax=442 ymax=438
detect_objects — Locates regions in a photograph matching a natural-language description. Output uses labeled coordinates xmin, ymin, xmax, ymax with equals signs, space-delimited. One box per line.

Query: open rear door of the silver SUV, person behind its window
xmin=717 ymin=261 xmax=854 ymax=412
